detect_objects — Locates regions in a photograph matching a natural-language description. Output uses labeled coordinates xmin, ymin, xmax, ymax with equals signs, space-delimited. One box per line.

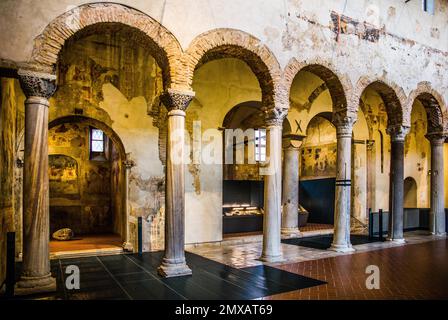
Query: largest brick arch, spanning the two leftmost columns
xmin=30 ymin=3 xmax=182 ymax=87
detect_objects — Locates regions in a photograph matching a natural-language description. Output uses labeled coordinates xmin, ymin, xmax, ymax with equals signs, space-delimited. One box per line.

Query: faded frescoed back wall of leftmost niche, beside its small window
xmin=48 ymin=122 xmax=115 ymax=235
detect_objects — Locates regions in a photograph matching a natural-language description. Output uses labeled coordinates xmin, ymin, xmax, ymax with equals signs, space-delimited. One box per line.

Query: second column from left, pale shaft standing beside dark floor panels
xmin=158 ymin=89 xmax=194 ymax=277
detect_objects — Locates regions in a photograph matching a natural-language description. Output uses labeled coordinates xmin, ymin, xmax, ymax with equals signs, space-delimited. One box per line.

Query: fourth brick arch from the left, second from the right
xmin=351 ymin=77 xmax=411 ymax=127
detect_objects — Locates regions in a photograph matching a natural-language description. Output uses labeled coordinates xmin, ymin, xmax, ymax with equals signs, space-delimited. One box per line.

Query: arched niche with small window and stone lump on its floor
xmin=48 ymin=116 xmax=127 ymax=254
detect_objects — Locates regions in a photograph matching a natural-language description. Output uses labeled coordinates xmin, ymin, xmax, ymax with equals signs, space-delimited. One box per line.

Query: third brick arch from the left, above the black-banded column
xmin=283 ymin=58 xmax=358 ymax=116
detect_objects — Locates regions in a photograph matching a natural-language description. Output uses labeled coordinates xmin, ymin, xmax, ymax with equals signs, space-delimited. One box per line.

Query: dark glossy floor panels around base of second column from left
xmin=7 ymin=252 xmax=326 ymax=300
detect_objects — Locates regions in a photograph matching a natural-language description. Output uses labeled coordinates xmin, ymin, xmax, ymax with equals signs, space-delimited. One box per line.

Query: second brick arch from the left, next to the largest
xmin=182 ymin=29 xmax=288 ymax=109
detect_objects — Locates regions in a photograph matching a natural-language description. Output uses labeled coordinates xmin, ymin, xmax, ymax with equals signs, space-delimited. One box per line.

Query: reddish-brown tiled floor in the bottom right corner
xmin=266 ymin=239 xmax=448 ymax=300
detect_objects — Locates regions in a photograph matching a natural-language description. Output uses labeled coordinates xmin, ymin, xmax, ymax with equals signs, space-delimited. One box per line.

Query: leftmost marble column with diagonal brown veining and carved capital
xmin=15 ymin=70 xmax=56 ymax=295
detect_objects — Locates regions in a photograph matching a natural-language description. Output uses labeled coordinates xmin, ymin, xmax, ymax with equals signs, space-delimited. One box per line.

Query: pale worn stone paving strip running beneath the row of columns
xmin=188 ymin=231 xmax=444 ymax=268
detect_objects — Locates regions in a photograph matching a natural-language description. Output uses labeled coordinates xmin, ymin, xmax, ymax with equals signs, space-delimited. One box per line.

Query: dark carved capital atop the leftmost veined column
xmin=17 ymin=69 xmax=56 ymax=100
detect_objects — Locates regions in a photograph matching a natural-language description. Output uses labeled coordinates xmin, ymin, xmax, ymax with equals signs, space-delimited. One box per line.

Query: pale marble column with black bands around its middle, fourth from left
xmin=329 ymin=117 xmax=355 ymax=252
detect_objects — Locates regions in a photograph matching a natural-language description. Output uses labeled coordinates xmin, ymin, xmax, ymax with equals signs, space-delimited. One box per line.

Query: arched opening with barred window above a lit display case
xmin=222 ymin=101 xmax=291 ymax=238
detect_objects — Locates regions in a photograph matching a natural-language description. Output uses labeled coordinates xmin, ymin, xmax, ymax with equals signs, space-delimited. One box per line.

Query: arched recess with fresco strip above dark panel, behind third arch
xmin=299 ymin=112 xmax=337 ymax=224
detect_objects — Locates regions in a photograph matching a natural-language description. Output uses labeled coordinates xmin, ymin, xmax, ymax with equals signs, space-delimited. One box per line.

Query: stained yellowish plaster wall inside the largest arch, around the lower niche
xmin=49 ymin=17 xmax=168 ymax=254
